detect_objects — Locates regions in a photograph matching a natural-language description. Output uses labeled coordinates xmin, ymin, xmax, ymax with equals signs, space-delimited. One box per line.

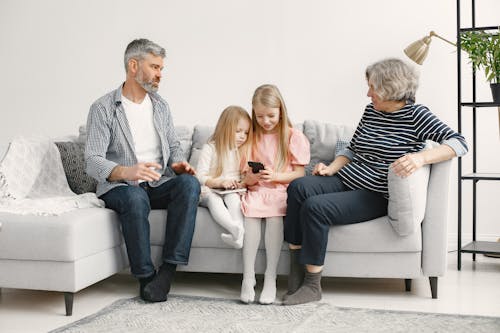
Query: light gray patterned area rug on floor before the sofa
xmin=50 ymin=295 xmax=500 ymax=333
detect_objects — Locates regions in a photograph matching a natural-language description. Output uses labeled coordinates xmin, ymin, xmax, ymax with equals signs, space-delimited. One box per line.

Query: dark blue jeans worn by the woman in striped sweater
xmin=284 ymin=175 xmax=388 ymax=266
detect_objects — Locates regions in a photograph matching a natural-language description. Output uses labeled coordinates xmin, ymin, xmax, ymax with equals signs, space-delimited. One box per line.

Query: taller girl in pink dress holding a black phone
xmin=240 ymin=85 xmax=310 ymax=304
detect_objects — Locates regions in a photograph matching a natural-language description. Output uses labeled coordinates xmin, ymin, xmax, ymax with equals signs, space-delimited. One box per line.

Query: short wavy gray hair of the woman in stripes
xmin=366 ymin=58 xmax=418 ymax=103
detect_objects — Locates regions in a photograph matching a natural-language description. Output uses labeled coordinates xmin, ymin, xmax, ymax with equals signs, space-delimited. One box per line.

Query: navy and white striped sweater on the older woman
xmin=338 ymin=104 xmax=467 ymax=196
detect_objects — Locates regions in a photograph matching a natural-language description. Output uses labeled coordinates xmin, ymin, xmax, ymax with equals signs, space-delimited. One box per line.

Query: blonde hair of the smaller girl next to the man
xmin=209 ymin=105 xmax=252 ymax=177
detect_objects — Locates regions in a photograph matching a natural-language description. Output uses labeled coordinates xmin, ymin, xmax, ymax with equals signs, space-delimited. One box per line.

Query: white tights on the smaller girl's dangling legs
xmin=201 ymin=193 xmax=244 ymax=249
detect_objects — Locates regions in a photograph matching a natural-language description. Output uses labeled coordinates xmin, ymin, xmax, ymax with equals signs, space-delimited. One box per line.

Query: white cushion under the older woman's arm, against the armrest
xmin=387 ymin=165 xmax=430 ymax=236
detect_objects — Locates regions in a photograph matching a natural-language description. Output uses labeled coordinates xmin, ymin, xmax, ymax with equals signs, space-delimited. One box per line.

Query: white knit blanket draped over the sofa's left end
xmin=0 ymin=137 xmax=104 ymax=215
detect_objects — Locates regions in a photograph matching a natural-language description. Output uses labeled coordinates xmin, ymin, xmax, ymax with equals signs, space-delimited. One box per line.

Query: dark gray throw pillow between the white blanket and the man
xmin=55 ymin=141 xmax=97 ymax=194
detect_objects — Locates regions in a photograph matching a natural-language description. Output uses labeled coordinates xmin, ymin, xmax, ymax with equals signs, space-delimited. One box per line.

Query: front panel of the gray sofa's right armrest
xmin=422 ymin=160 xmax=452 ymax=276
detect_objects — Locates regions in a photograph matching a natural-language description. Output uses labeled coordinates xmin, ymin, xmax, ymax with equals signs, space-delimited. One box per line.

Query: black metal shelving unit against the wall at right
xmin=457 ymin=0 xmax=500 ymax=270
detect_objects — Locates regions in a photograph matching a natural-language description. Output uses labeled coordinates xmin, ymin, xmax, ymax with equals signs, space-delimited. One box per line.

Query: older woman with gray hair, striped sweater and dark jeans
xmin=283 ymin=59 xmax=467 ymax=305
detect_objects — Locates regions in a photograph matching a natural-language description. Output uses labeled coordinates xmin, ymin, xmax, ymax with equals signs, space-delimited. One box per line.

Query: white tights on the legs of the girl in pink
xmin=241 ymin=216 xmax=283 ymax=304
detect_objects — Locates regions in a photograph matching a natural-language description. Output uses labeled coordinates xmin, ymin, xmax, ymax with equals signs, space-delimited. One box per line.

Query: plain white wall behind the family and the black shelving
xmin=0 ymin=0 xmax=500 ymax=246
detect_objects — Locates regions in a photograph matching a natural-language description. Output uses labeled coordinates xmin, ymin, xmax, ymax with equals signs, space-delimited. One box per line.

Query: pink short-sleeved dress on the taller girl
xmin=241 ymin=128 xmax=310 ymax=218
